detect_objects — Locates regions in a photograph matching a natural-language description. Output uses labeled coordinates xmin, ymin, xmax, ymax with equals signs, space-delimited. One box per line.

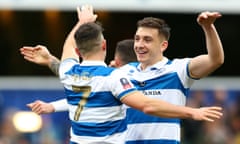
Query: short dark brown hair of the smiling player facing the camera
xmin=137 ymin=17 xmax=171 ymax=40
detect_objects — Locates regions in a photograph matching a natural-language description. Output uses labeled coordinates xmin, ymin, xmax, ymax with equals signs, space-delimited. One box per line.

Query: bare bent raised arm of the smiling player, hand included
xmin=189 ymin=11 xmax=224 ymax=78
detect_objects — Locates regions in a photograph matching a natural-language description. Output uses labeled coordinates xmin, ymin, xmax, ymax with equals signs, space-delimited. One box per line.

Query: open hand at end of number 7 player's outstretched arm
xmin=193 ymin=106 xmax=223 ymax=122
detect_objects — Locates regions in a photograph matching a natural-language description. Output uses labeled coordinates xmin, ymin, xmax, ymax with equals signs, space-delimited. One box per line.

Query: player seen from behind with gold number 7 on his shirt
xmin=21 ymin=6 xmax=222 ymax=144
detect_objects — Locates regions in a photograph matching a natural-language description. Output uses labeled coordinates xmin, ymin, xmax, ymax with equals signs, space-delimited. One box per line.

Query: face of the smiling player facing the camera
xmin=134 ymin=27 xmax=163 ymax=67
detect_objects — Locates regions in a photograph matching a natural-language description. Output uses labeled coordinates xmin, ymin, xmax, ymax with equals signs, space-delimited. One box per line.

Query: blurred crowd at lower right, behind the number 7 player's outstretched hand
xmin=182 ymin=87 xmax=240 ymax=144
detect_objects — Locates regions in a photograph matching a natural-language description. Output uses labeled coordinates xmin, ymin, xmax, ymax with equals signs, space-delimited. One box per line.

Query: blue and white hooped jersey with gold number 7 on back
xmin=59 ymin=59 xmax=136 ymax=144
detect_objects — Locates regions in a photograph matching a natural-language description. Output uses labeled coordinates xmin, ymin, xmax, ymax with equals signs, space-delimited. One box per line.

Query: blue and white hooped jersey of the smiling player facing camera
xmin=121 ymin=58 xmax=194 ymax=144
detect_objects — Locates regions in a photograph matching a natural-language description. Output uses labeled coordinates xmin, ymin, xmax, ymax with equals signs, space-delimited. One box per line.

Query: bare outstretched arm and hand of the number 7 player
xmin=122 ymin=92 xmax=222 ymax=122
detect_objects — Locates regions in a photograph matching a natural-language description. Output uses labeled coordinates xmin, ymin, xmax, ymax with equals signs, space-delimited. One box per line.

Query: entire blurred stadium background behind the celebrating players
xmin=0 ymin=0 xmax=240 ymax=144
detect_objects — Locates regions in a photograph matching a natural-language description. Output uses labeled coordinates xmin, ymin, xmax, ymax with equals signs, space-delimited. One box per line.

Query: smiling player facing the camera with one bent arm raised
xmin=19 ymin=6 xmax=224 ymax=144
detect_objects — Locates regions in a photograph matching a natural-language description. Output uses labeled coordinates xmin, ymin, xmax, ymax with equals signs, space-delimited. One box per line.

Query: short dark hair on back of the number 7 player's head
xmin=74 ymin=22 xmax=103 ymax=55
